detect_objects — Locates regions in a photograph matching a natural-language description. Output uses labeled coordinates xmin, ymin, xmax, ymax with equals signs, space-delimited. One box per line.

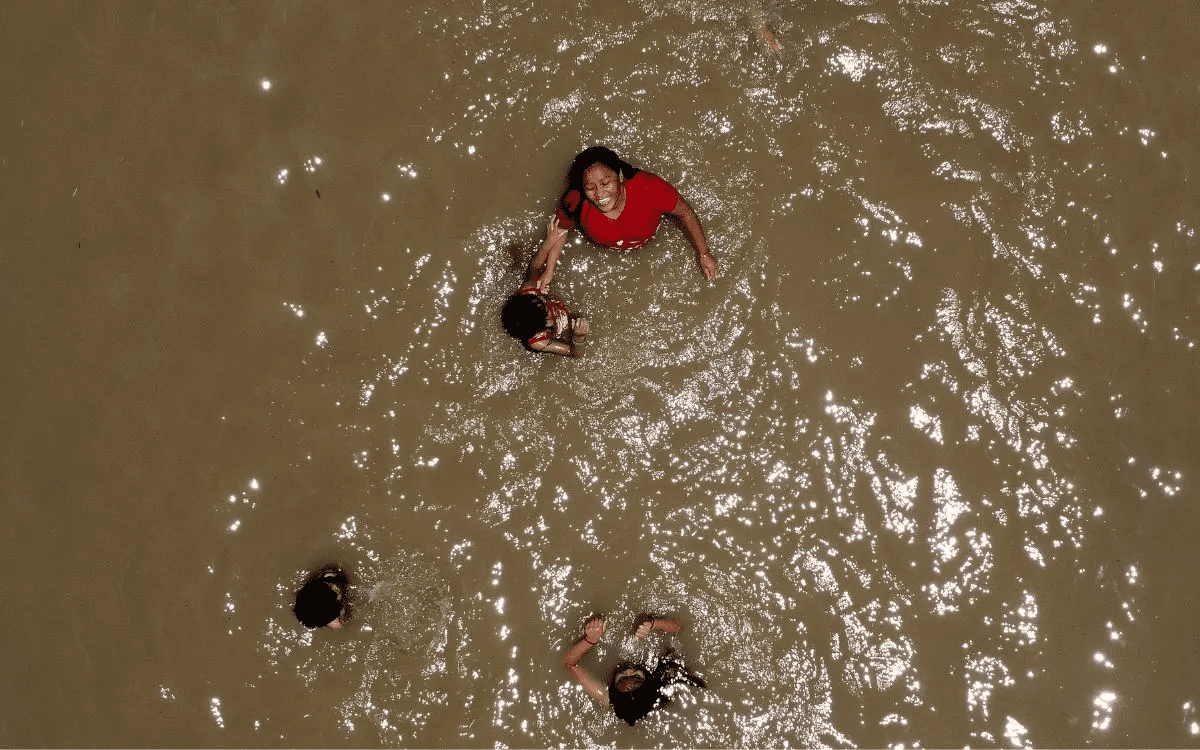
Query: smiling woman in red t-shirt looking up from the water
xmin=529 ymin=146 xmax=716 ymax=292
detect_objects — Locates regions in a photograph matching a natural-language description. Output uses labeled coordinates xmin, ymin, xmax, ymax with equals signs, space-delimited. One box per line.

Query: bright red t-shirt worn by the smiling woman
xmin=558 ymin=172 xmax=679 ymax=250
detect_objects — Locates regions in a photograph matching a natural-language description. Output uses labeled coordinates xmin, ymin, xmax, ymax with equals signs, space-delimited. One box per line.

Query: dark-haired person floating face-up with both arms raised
xmin=563 ymin=614 xmax=704 ymax=726
